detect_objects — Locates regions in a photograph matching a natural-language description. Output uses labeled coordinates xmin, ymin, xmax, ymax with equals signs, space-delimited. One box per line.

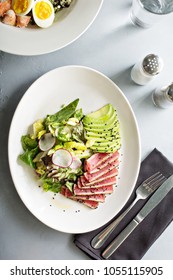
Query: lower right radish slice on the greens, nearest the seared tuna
xmin=52 ymin=149 xmax=73 ymax=168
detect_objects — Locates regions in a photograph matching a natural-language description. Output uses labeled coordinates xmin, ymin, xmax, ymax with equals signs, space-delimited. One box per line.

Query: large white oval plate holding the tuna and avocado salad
xmin=8 ymin=66 xmax=140 ymax=233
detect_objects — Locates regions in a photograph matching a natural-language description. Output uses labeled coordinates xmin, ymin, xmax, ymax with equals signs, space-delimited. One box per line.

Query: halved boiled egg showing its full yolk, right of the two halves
xmin=32 ymin=0 xmax=55 ymax=28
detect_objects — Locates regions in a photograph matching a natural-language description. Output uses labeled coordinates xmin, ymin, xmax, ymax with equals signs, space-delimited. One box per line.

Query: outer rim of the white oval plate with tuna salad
xmin=8 ymin=65 xmax=141 ymax=234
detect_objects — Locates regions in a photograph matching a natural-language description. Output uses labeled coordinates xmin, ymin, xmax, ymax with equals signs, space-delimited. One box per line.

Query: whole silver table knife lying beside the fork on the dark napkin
xmin=102 ymin=175 xmax=173 ymax=259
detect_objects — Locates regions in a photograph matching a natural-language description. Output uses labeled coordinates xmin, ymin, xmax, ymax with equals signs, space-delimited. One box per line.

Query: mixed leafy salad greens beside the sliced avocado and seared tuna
xmin=19 ymin=99 xmax=92 ymax=192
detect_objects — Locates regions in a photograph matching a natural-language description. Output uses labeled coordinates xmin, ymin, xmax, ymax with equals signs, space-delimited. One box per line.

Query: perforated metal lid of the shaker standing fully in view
xmin=142 ymin=54 xmax=163 ymax=76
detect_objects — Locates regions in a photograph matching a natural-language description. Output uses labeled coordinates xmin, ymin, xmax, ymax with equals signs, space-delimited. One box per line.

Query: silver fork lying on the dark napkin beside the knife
xmin=91 ymin=172 xmax=166 ymax=249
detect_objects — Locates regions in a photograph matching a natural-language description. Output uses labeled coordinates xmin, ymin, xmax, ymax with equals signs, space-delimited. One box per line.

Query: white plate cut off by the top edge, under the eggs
xmin=0 ymin=0 xmax=103 ymax=55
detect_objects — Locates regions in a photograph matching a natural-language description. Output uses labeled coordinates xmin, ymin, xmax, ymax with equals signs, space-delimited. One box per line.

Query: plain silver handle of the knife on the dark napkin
xmin=102 ymin=219 xmax=139 ymax=259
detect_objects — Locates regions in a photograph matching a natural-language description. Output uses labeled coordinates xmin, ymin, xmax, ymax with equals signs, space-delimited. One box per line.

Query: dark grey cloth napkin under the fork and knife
xmin=74 ymin=149 xmax=173 ymax=260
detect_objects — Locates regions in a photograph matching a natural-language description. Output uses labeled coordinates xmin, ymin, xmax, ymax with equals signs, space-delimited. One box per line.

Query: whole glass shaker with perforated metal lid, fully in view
xmin=131 ymin=54 xmax=163 ymax=85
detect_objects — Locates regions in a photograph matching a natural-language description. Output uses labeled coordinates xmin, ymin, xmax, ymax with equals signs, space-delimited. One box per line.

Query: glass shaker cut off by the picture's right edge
xmin=152 ymin=83 xmax=173 ymax=109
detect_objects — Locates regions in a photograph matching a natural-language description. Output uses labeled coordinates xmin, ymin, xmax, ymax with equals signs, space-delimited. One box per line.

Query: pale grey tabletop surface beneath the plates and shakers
xmin=0 ymin=0 xmax=173 ymax=260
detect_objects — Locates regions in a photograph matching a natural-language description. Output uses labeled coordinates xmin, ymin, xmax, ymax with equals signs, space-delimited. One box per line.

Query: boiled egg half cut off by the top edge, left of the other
xmin=12 ymin=0 xmax=34 ymax=16
